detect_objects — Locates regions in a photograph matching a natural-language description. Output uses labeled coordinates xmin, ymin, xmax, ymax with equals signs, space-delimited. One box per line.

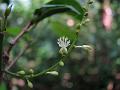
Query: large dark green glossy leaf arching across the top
xmin=33 ymin=0 xmax=85 ymax=22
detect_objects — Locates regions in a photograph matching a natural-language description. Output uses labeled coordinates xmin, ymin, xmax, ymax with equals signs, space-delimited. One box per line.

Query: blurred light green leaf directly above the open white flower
xmin=51 ymin=21 xmax=76 ymax=40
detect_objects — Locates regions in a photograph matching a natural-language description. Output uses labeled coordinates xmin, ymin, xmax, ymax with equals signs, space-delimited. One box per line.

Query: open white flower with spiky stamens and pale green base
xmin=57 ymin=36 xmax=70 ymax=55
